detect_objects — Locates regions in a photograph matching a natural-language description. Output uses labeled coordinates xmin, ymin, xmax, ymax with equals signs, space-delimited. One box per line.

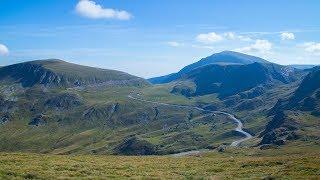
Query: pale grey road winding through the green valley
xmin=128 ymin=95 xmax=252 ymax=148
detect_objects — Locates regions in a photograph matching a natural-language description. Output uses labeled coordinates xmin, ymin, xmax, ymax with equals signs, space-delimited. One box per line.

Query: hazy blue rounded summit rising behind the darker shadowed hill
xmin=149 ymin=51 xmax=270 ymax=84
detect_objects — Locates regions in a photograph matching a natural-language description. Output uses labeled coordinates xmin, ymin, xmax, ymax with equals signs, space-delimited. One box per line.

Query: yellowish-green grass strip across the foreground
xmin=0 ymin=144 xmax=320 ymax=179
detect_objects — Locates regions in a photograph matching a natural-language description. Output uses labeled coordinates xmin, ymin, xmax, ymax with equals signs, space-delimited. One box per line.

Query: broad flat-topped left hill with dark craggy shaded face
xmin=0 ymin=59 xmax=148 ymax=87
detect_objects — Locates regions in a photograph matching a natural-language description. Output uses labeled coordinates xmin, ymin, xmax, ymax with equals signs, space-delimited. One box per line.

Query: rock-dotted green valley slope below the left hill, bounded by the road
xmin=0 ymin=83 xmax=239 ymax=154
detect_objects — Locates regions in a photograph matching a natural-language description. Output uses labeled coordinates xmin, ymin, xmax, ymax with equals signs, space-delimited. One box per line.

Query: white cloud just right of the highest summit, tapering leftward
xmin=236 ymin=39 xmax=272 ymax=53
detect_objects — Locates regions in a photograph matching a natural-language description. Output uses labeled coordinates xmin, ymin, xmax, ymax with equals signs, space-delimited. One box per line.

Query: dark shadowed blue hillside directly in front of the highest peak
xmin=172 ymin=63 xmax=296 ymax=97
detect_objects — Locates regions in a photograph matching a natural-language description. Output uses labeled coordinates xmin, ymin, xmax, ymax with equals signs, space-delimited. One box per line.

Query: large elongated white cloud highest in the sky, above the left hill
xmin=76 ymin=0 xmax=132 ymax=20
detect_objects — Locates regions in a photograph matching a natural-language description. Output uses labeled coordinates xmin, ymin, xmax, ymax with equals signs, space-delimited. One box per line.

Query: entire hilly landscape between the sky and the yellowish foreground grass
xmin=0 ymin=51 xmax=320 ymax=155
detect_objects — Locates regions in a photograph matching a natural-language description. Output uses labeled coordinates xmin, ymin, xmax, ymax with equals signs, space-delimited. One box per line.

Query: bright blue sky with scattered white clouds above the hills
xmin=0 ymin=0 xmax=320 ymax=78
